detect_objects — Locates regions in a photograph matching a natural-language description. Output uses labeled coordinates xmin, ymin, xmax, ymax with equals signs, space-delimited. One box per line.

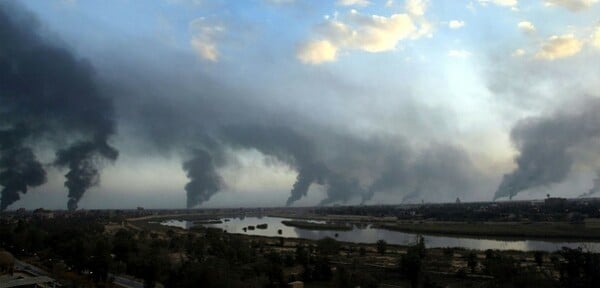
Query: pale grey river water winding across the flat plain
xmin=161 ymin=217 xmax=600 ymax=252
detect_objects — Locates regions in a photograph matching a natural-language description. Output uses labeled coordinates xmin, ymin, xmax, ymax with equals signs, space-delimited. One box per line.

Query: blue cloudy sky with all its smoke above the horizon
xmin=0 ymin=0 xmax=600 ymax=209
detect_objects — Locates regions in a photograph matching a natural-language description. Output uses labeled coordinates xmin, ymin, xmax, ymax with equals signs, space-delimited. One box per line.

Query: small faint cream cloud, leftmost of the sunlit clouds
xmin=190 ymin=17 xmax=225 ymax=62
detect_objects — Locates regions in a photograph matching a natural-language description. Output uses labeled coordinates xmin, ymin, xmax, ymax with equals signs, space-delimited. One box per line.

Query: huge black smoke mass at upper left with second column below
xmin=0 ymin=1 xmax=118 ymax=208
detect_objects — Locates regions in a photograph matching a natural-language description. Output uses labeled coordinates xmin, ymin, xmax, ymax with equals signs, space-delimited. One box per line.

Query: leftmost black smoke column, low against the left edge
xmin=0 ymin=126 xmax=46 ymax=211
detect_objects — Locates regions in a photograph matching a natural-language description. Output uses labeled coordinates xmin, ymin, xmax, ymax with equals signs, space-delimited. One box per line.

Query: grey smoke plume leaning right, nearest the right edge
xmin=494 ymin=98 xmax=600 ymax=199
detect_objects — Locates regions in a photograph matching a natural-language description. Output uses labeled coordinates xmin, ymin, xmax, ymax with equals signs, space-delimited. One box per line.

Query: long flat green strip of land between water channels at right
xmin=375 ymin=222 xmax=600 ymax=240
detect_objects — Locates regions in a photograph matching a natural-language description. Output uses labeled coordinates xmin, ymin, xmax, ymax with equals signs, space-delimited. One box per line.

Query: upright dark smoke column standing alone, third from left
xmin=183 ymin=149 xmax=223 ymax=208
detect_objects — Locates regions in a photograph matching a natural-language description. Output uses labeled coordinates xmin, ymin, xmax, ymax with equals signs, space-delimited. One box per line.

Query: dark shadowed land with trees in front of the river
xmin=0 ymin=207 xmax=600 ymax=287
